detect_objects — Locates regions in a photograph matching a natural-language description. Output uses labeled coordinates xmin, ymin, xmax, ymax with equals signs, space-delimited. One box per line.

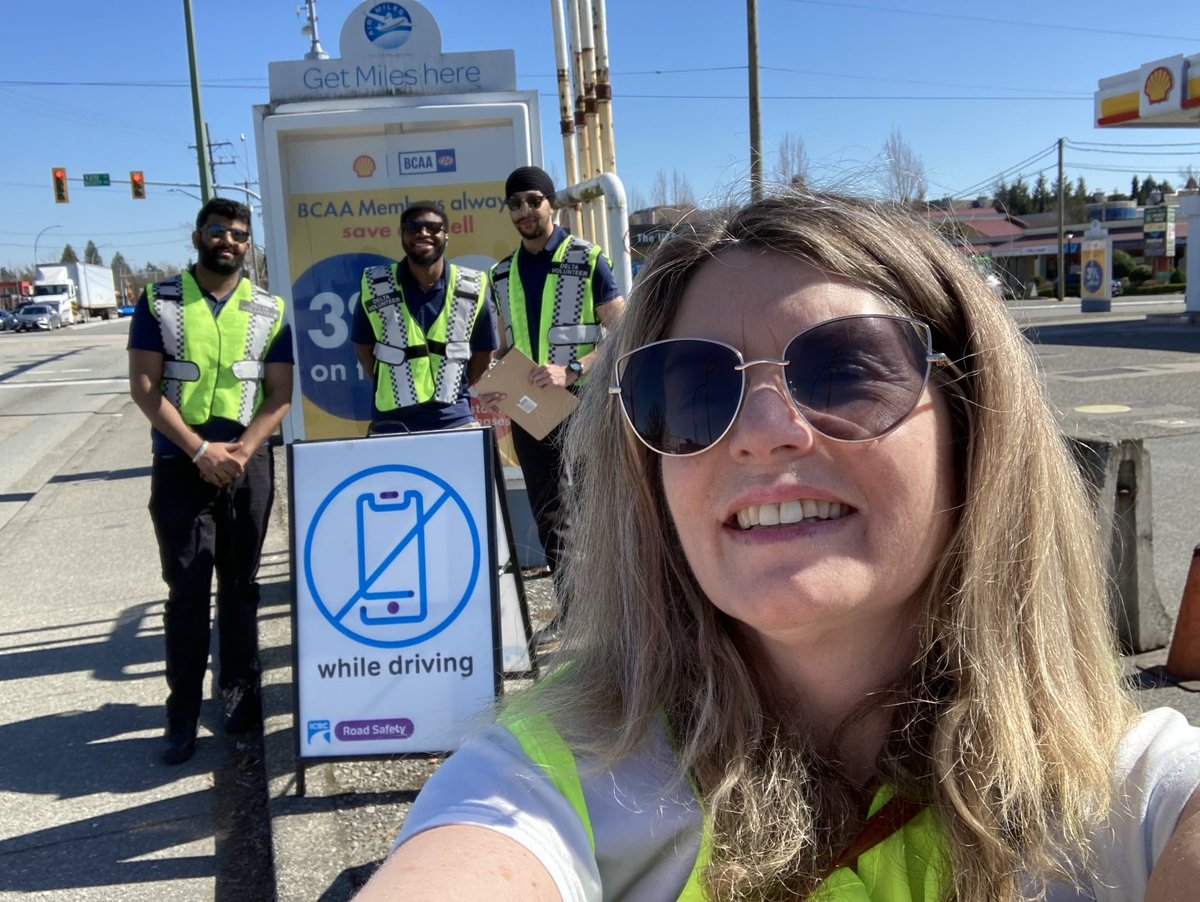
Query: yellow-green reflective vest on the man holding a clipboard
xmin=490 ymin=235 xmax=604 ymax=366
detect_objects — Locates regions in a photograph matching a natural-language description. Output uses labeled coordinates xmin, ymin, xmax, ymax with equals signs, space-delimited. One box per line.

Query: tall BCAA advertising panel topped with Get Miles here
xmin=256 ymin=0 xmax=541 ymax=448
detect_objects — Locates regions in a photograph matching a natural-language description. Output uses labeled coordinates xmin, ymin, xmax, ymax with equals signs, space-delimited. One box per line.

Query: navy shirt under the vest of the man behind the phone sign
xmin=350 ymin=259 xmax=499 ymax=432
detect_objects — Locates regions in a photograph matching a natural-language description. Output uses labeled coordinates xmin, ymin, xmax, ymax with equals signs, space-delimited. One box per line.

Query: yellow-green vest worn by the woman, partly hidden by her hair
xmin=504 ymin=715 xmax=948 ymax=902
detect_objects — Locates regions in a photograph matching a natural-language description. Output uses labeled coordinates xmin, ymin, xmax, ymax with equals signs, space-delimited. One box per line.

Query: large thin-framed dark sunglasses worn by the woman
xmin=608 ymin=314 xmax=949 ymax=457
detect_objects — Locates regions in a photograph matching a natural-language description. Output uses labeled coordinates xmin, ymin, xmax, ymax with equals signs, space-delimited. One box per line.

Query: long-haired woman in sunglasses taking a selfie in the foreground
xmin=361 ymin=194 xmax=1200 ymax=902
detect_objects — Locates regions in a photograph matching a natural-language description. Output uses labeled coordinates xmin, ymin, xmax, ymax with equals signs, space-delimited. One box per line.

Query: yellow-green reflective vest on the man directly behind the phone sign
xmin=361 ymin=264 xmax=484 ymax=410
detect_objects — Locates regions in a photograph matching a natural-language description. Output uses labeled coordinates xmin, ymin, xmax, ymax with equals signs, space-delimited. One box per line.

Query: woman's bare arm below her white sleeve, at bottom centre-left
xmin=355 ymin=825 xmax=562 ymax=902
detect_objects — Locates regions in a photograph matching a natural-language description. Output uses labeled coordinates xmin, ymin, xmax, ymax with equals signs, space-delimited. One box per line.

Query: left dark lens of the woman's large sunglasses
xmin=618 ymin=338 xmax=742 ymax=455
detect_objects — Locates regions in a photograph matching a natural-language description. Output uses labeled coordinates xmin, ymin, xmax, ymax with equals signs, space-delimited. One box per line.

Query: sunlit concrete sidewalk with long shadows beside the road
xmin=0 ymin=396 xmax=288 ymax=902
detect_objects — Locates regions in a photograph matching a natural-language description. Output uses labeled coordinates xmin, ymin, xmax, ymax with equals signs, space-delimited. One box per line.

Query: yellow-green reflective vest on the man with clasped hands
xmin=146 ymin=272 xmax=283 ymax=426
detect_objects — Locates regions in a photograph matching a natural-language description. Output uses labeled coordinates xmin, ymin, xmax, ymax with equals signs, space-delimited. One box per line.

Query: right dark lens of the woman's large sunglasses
xmin=784 ymin=317 xmax=929 ymax=441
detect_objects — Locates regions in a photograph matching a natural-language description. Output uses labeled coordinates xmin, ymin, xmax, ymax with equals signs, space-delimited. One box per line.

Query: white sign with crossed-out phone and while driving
xmin=289 ymin=429 xmax=502 ymax=758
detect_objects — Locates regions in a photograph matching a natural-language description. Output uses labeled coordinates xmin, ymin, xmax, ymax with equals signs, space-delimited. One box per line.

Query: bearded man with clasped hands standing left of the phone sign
xmin=128 ymin=198 xmax=293 ymax=764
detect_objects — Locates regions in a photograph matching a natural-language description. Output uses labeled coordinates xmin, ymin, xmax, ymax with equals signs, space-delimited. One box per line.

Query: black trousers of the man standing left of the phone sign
xmin=150 ymin=446 xmax=275 ymax=722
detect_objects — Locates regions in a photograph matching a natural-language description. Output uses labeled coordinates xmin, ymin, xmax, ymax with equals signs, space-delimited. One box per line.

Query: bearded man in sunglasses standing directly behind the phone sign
xmin=350 ymin=200 xmax=497 ymax=435
